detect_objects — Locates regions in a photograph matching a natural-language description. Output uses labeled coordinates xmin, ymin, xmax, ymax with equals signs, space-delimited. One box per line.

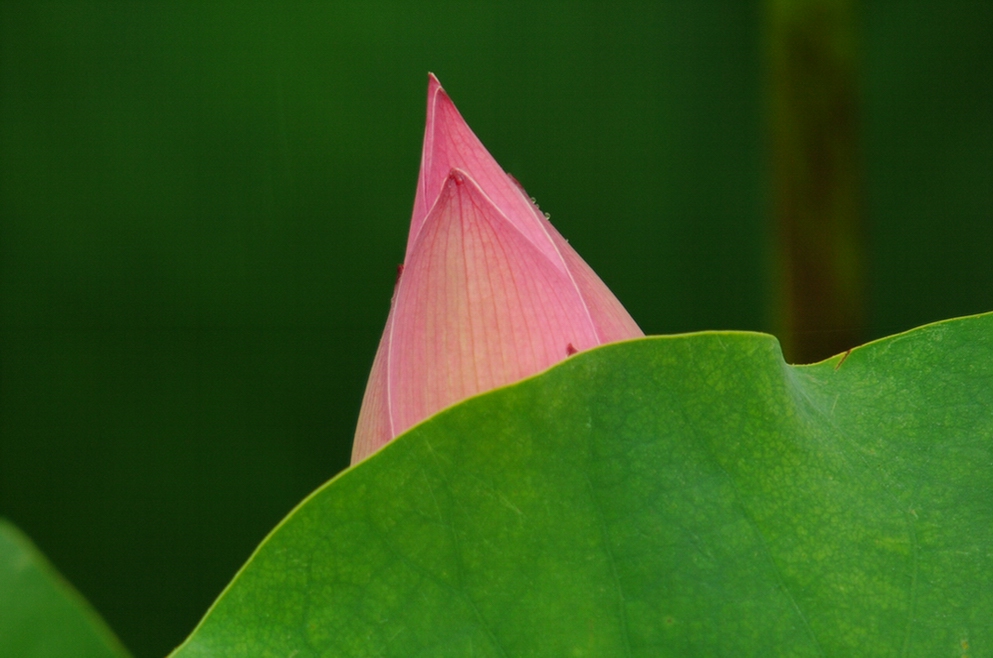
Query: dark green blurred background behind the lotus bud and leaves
xmin=0 ymin=0 xmax=993 ymax=657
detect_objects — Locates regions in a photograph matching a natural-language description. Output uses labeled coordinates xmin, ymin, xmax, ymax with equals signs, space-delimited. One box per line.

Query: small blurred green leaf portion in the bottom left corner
xmin=0 ymin=519 xmax=130 ymax=658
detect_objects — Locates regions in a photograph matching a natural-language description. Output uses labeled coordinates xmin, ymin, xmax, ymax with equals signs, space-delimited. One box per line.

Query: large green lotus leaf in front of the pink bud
xmin=174 ymin=314 xmax=993 ymax=658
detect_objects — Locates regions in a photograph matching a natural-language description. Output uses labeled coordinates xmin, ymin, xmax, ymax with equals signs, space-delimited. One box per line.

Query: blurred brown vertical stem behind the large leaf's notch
xmin=766 ymin=0 xmax=864 ymax=363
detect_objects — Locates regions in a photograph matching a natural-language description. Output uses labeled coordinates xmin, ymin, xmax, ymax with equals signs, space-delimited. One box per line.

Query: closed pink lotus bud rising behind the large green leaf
xmin=352 ymin=75 xmax=644 ymax=464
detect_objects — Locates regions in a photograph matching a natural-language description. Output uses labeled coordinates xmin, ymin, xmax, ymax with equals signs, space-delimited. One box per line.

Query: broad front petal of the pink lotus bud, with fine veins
xmin=389 ymin=170 xmax=599 ymax=433
